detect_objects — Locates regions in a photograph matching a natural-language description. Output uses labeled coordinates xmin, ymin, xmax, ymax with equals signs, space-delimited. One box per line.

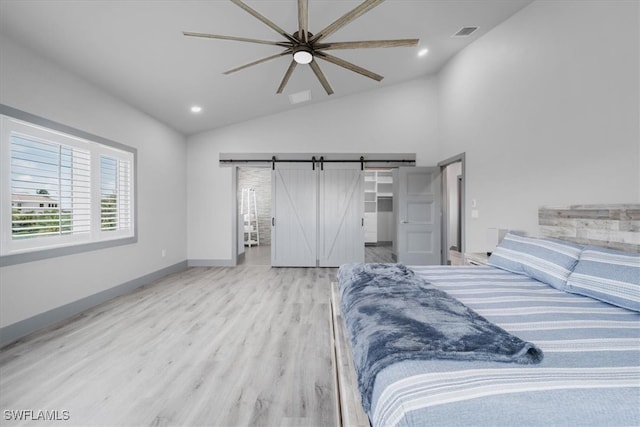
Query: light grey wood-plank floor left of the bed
xmin=0 ymin=266 xmax=337 ymax=426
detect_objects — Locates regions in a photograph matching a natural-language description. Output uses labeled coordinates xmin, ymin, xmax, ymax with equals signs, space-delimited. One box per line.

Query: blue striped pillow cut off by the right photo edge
xmin=565 ymin=246 xmax=640 ymax=311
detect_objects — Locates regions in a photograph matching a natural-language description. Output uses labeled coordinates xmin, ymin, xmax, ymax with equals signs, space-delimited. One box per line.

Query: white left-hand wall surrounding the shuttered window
xmin=0 ymin=37 xmax=186 ymax=327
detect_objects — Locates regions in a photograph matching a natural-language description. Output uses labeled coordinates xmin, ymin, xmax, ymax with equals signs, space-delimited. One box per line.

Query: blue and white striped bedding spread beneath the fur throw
xmin=369 ymin=266 xmax=640 ymax=427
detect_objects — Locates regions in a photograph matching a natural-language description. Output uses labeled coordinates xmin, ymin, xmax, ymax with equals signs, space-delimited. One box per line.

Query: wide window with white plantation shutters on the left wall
xmin=0 ymin=109 xmax=135 ymax=262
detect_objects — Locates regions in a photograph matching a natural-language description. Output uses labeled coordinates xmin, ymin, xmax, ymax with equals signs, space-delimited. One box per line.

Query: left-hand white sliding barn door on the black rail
xmin=271 ymin=164 xmax=318 ymax=267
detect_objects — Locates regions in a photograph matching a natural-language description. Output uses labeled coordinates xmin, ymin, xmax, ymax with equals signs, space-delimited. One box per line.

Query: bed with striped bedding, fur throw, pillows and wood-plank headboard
xmin=332 ymin=205 xmax=640 ymax=426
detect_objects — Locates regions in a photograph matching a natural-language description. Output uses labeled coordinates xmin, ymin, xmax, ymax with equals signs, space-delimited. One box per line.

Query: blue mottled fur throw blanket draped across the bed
xmin=338 ymin=264 xmax=542 ymax=413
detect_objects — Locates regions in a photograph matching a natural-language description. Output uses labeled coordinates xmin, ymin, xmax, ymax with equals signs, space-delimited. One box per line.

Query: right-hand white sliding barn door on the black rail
xmin=318 ymin=163 xmax=364 ymax=267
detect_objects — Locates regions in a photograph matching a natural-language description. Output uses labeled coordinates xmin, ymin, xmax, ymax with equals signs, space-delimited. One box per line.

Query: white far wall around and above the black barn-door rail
xmin=187 ymin=78 xmax=440 ymax=261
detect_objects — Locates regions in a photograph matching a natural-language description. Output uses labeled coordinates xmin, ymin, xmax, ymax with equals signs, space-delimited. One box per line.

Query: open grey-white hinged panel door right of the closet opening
xmin=397 ymin=167 xmax=442 ymax=265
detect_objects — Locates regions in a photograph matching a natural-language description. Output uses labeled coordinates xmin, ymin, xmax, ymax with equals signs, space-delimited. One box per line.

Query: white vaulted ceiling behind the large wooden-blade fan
xmin=0 ymin=0 xmax=531 ymax=134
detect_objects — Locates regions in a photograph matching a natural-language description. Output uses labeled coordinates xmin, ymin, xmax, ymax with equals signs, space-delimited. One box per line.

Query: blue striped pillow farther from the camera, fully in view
xmin=489 ymin=233 xmax=582 ymax=290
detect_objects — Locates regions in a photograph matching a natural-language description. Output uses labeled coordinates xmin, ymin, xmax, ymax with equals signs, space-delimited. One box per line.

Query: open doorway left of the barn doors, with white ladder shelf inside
xmin=236 ymin=167 xmax=271 ymax=265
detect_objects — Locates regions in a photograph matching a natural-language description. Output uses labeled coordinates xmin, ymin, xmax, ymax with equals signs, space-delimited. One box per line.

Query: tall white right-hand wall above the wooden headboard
xmin=438 ymin=1 xmax=640 ymax=251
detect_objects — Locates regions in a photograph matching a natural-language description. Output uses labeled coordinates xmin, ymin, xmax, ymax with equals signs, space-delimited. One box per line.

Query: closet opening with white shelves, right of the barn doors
xmin=364 ymin=168 xmax=396 ymax=263
